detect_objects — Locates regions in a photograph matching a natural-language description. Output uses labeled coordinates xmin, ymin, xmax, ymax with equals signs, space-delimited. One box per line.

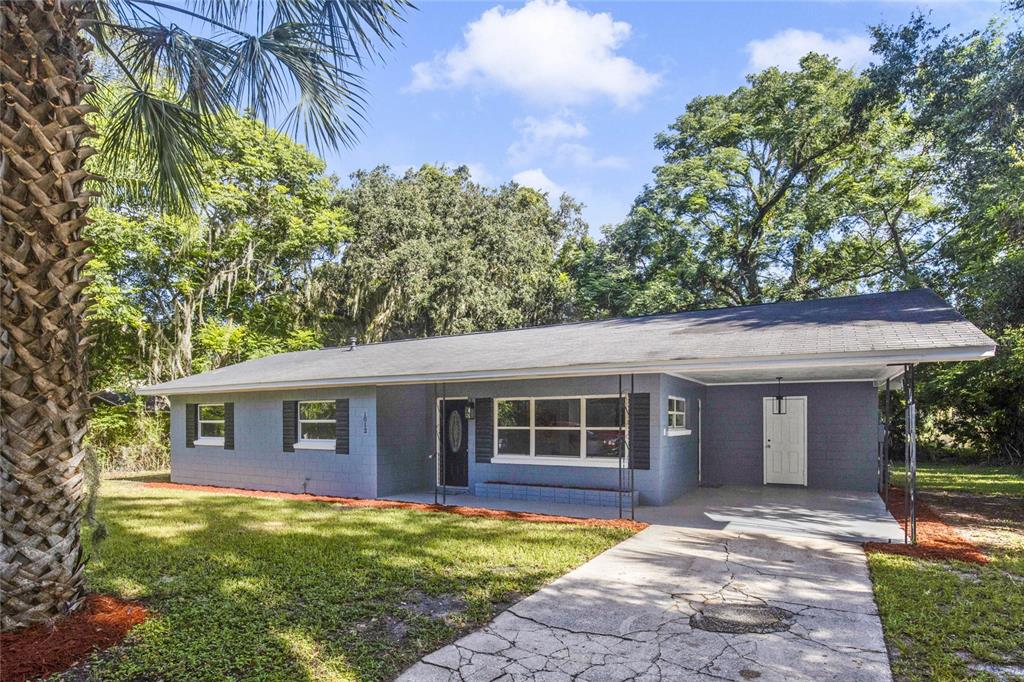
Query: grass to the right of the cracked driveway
xmin=868 ymin=464 xmax=1024 ymax=680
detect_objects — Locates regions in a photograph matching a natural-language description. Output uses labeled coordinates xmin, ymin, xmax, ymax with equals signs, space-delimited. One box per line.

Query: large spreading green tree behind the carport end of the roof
xmin=571 ymin=54 xmax=939 ymax=313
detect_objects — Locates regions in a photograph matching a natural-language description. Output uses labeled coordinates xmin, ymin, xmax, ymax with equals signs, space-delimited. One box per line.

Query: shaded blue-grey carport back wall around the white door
xmin=703 ymin=381 xmax=879 ymax=491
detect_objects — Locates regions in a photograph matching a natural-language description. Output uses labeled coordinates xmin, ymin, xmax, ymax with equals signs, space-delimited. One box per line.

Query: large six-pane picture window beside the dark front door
xmin=495 ymin=395 xmax=626 ymax=465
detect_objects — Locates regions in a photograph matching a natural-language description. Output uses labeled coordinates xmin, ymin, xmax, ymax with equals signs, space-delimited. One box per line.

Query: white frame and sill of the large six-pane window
xmin=490 ymin=393 xmax=630 ymax=467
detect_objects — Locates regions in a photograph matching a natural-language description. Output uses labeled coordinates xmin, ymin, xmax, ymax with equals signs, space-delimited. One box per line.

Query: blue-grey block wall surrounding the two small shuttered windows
xmin=171 ymin=388 xmax=377 ymax=498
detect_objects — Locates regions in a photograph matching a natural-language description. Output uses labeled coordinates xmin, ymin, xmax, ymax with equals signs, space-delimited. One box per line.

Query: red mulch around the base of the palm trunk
xmin=0 ymin=594 xmax=148 ymax=682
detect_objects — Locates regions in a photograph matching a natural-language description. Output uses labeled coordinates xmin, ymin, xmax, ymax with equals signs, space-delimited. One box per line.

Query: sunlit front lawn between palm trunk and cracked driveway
xmin=75 ymin=480 xmax=631 ymax=680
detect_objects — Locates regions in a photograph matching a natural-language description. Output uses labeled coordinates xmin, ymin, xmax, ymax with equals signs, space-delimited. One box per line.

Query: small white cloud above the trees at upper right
xmin=746 ymin=29 xmax=871 ymax=71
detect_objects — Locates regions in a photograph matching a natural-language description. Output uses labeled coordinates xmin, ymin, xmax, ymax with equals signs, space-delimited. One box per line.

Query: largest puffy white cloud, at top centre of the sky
xmin=409 ymin=0 xmax=658 ymax=106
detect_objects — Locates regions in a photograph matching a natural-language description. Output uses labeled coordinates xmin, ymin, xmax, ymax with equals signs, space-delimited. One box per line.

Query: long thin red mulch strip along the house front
xmin=142 ymin=481 xmax=647 ymax=530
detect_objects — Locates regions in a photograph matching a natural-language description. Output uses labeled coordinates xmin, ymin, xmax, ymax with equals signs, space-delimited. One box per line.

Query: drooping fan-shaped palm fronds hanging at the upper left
xmin=82 ymin=0 xmax=412 ymax=209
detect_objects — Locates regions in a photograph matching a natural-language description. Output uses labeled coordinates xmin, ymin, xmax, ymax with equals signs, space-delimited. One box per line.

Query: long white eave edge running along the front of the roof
xmin=136 ymin=343 xmax=995 ymax=395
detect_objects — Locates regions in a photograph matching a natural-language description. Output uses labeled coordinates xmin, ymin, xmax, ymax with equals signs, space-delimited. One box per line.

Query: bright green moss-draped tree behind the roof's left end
xmin=88 ymin=105 xmax=350 ymax=387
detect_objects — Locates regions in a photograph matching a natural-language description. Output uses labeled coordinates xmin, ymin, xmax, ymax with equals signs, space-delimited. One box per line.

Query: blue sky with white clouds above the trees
xmin=326 ymin=0 xmax=999 ymax=235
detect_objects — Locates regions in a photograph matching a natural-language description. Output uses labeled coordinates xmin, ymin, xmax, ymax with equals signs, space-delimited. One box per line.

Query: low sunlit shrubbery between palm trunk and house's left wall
xmin=86 ymin=399 xmax=171 ymax=471
